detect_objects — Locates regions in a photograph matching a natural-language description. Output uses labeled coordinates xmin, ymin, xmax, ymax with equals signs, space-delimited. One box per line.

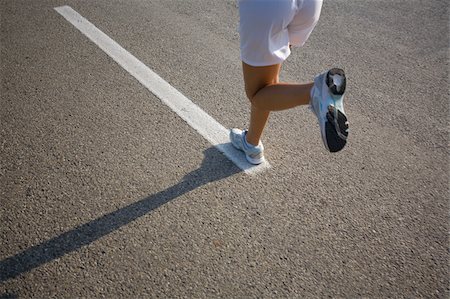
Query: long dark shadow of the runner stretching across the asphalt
xmin=0 ymin=147 xmax=241 ymax=282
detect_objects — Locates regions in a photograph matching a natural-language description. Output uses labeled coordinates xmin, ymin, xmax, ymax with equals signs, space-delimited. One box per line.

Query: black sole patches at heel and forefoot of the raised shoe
xmin=325 ymin=68 xmax=348 ymax=153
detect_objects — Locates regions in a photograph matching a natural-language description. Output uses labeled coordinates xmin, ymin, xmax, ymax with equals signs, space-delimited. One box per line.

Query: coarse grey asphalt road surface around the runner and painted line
xmin=0 ymin=0 xmax=449 ymax=298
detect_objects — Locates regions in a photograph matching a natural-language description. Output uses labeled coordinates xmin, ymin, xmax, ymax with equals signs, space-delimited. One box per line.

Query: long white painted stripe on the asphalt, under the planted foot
xmin=55 ymin=6 xmax=270 ymax=174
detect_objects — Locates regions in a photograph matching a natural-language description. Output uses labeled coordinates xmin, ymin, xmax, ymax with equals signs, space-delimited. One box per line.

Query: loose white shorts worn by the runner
xmin=239 ymin=0 xmax=323 ymax=66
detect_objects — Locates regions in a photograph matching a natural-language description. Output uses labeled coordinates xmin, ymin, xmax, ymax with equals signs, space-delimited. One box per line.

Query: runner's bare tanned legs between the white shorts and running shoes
xmin=242 ymin=62 xmax=314 ymax=145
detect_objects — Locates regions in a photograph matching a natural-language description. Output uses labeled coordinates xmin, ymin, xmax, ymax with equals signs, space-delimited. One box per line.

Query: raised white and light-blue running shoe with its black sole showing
xmin=310 ymin=68 xmax=348 ymax=152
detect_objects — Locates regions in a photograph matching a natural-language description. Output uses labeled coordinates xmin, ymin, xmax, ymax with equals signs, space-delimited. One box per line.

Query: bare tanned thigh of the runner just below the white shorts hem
xmin=242 ymin=62 xmax=281 ymax=100
